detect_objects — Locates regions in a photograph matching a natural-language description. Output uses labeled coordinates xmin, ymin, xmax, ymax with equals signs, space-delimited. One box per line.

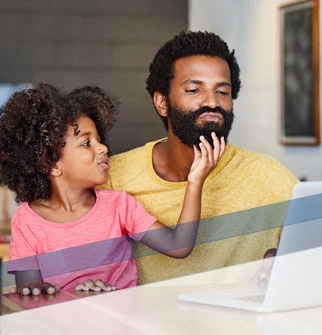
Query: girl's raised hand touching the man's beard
xmin=188 ymin=132 xmax=226 ymax=184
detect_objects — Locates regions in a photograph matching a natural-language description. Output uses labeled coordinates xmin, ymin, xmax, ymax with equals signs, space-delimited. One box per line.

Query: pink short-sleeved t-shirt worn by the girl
xmin=8 ymin=190 xmax=156 ymax=290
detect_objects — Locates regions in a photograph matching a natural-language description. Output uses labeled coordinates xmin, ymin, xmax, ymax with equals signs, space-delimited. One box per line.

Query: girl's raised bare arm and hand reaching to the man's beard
xmin=141 ymin=133 xmax=225 ymax=258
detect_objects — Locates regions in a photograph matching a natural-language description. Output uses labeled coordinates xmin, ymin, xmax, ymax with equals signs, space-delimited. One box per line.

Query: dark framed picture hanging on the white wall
xmin=279 ymin=0 xmax=320 ymax=145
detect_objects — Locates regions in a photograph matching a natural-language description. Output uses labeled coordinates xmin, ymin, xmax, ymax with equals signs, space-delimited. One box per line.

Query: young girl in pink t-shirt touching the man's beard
xmin=0 ymin=84 xmax=225 ymax=295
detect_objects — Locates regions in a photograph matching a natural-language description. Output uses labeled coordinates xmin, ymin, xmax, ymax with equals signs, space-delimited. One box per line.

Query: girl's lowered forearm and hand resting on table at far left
xmin=10 ymin=270 xmax=59 ymax=295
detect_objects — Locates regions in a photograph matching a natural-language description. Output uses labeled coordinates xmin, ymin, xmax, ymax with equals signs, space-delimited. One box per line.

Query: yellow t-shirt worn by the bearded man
xmin=102 ymin=139 xmax=298 ymax=284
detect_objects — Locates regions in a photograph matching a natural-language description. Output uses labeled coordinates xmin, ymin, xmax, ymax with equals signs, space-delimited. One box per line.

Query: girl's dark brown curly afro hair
xmin=0 ymin=83 xmax=118 ymax=203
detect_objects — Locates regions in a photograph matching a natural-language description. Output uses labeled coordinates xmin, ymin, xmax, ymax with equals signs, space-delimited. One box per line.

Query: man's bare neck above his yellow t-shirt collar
xmin=152 ymin=132 xmax=194 ymax=182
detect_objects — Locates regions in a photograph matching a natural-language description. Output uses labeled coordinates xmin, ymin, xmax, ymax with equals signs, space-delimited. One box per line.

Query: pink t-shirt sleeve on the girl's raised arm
xmin=123 ymin=192 xmax=157 ymax=241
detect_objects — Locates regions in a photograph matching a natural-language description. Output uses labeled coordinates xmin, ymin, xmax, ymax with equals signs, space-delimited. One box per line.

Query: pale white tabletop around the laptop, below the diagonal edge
xmin=0 ymin=262 xmax=322 ymax=335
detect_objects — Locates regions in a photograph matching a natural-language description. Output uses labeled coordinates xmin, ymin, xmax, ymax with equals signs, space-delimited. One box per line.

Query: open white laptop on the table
xmin=178 ymin=181 xmax=322 ymax=313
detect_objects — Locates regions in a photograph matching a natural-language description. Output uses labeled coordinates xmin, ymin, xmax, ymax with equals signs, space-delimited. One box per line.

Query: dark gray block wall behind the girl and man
xmin=0 ymin=0 xmax=188 ymax=154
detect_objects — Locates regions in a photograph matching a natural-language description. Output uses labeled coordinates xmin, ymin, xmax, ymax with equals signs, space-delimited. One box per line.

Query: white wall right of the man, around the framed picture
xmin=189 ymin=0 xmax=322 ymax=180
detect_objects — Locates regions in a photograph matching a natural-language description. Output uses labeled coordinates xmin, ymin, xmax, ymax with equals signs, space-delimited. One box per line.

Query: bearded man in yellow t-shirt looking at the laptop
xmin=104 ymin=32 xmax=297 ymax=284
